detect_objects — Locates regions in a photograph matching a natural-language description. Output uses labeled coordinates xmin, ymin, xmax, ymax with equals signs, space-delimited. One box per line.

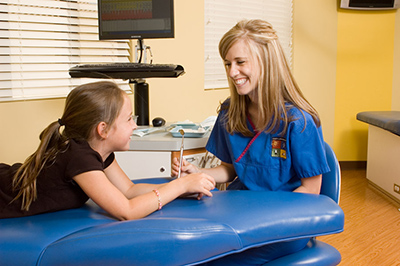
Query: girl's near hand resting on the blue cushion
xmin=175 ymin=173 xmax=215 ymax=199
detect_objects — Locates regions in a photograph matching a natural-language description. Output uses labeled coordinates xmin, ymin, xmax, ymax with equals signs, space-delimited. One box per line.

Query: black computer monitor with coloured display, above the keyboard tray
xmin=98 ymin=0 xmax=174 ymax=40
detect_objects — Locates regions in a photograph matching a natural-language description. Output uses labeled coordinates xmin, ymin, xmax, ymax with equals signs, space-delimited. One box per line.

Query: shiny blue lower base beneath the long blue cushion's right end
xmin=264 ymin=238 xmax=342 ymax=266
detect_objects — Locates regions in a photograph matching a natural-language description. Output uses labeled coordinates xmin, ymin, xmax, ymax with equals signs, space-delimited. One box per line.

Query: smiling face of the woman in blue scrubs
xmin=224 ymin=40 xmax=259 ymax=99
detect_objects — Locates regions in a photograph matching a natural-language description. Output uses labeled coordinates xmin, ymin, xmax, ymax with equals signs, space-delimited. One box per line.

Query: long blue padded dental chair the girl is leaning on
xmin=0 ymin=178 xmax=344 ymax=266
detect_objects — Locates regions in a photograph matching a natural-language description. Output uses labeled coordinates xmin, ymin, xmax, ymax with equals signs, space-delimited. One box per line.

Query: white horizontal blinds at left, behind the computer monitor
xmin=0 ymin=0 xmax=130 ymax=101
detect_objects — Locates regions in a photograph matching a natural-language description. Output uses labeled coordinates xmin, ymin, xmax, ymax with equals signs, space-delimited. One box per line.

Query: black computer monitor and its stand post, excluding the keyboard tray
xmin=98 ymin=0 xmax=175 ymax=125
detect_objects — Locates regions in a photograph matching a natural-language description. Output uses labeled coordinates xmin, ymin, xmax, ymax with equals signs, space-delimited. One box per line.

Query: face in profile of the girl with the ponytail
xmin=108 ymin=96 xmax=137 ymax=151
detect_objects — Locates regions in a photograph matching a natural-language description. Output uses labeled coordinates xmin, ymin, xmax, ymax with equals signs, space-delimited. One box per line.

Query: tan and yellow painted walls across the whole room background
xmin=0 ymin=0 xmax=400 ymax=163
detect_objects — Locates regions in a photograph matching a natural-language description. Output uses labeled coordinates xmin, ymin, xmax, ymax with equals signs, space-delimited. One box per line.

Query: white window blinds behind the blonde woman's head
xmin=204 ymin=0 xmax=292 ymax=89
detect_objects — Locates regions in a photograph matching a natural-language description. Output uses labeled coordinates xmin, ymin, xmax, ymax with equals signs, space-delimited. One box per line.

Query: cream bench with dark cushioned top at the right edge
xmin=357 ymin=111 xmax=400 ymax=202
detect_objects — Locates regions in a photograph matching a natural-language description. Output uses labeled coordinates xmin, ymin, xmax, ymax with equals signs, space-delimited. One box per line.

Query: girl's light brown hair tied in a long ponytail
xmin=12 ymin=81 xmax=125 ymax=210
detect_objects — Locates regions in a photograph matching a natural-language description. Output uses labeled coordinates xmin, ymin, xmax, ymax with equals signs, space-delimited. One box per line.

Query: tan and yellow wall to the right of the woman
xmin=293 ymin=0 xmax=400 ymax=161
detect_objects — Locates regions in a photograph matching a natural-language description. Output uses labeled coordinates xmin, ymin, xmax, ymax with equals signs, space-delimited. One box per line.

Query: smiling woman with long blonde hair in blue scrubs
xmin=172 ymin=20 xmax=329 ymax=265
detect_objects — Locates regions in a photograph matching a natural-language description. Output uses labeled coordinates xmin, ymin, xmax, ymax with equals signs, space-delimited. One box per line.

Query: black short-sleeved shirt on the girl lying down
xmin=0 ymin=140 xmax=115 ymax=218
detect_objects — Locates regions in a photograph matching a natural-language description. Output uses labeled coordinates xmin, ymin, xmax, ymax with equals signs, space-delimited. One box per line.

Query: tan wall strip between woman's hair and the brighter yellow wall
xmin=293 ymin=0 xmax=337 ymax=146
